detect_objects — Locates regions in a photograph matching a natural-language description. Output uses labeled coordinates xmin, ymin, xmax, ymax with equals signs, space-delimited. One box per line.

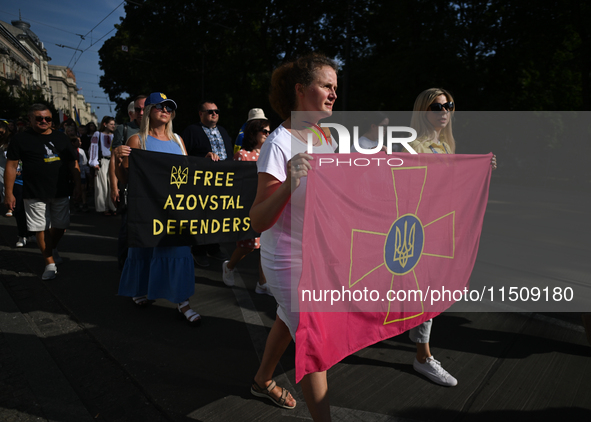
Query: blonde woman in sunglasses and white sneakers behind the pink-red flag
xmin=409 ymin=88 xmax=497 ymax=387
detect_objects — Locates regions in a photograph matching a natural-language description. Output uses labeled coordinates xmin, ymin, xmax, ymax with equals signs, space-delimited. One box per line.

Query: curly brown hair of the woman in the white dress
xmin=269 ymin=53 xmax=338 ymax=119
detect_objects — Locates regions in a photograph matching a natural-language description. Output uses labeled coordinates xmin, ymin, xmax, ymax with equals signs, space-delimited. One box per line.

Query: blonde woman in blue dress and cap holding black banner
xmin=116 ymin=92 xmax=201 ymax=325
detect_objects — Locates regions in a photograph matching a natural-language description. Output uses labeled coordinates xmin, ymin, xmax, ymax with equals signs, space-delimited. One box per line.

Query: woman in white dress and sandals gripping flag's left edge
xmin=250 ymin=54 xmax=337 ymax=421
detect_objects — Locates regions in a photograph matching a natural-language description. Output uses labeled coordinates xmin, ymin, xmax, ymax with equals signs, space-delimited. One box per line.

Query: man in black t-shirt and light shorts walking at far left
xmin=4 ymin=104 xmax=81 ymax=280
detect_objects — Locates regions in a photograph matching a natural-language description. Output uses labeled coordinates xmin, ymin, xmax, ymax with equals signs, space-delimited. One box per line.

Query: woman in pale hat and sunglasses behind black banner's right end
xmin=222 ymin=114 xmax=273 ymax=296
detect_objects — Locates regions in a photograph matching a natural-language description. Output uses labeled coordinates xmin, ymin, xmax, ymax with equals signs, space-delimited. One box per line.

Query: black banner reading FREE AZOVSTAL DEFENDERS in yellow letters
xmin=127 ymin=149 xmax=258 ymax=247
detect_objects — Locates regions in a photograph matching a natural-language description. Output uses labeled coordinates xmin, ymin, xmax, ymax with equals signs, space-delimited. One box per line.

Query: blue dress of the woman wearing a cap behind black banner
xmin=119 ymin=136 xmax=195 ymax=303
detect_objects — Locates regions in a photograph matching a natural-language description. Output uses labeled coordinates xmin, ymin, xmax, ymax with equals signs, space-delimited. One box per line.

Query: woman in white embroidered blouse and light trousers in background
xmin=88 ymin=116 xmax=117 ymax=216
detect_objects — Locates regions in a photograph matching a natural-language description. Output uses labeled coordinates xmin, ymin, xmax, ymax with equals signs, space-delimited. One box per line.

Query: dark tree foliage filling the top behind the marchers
xmin=100 ymin=0 xmax=591 ymax=188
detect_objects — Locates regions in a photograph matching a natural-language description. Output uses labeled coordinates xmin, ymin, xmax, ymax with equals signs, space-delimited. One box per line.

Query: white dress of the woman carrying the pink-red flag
xmin=257 ymin=125 xmax=337 ymax=269
